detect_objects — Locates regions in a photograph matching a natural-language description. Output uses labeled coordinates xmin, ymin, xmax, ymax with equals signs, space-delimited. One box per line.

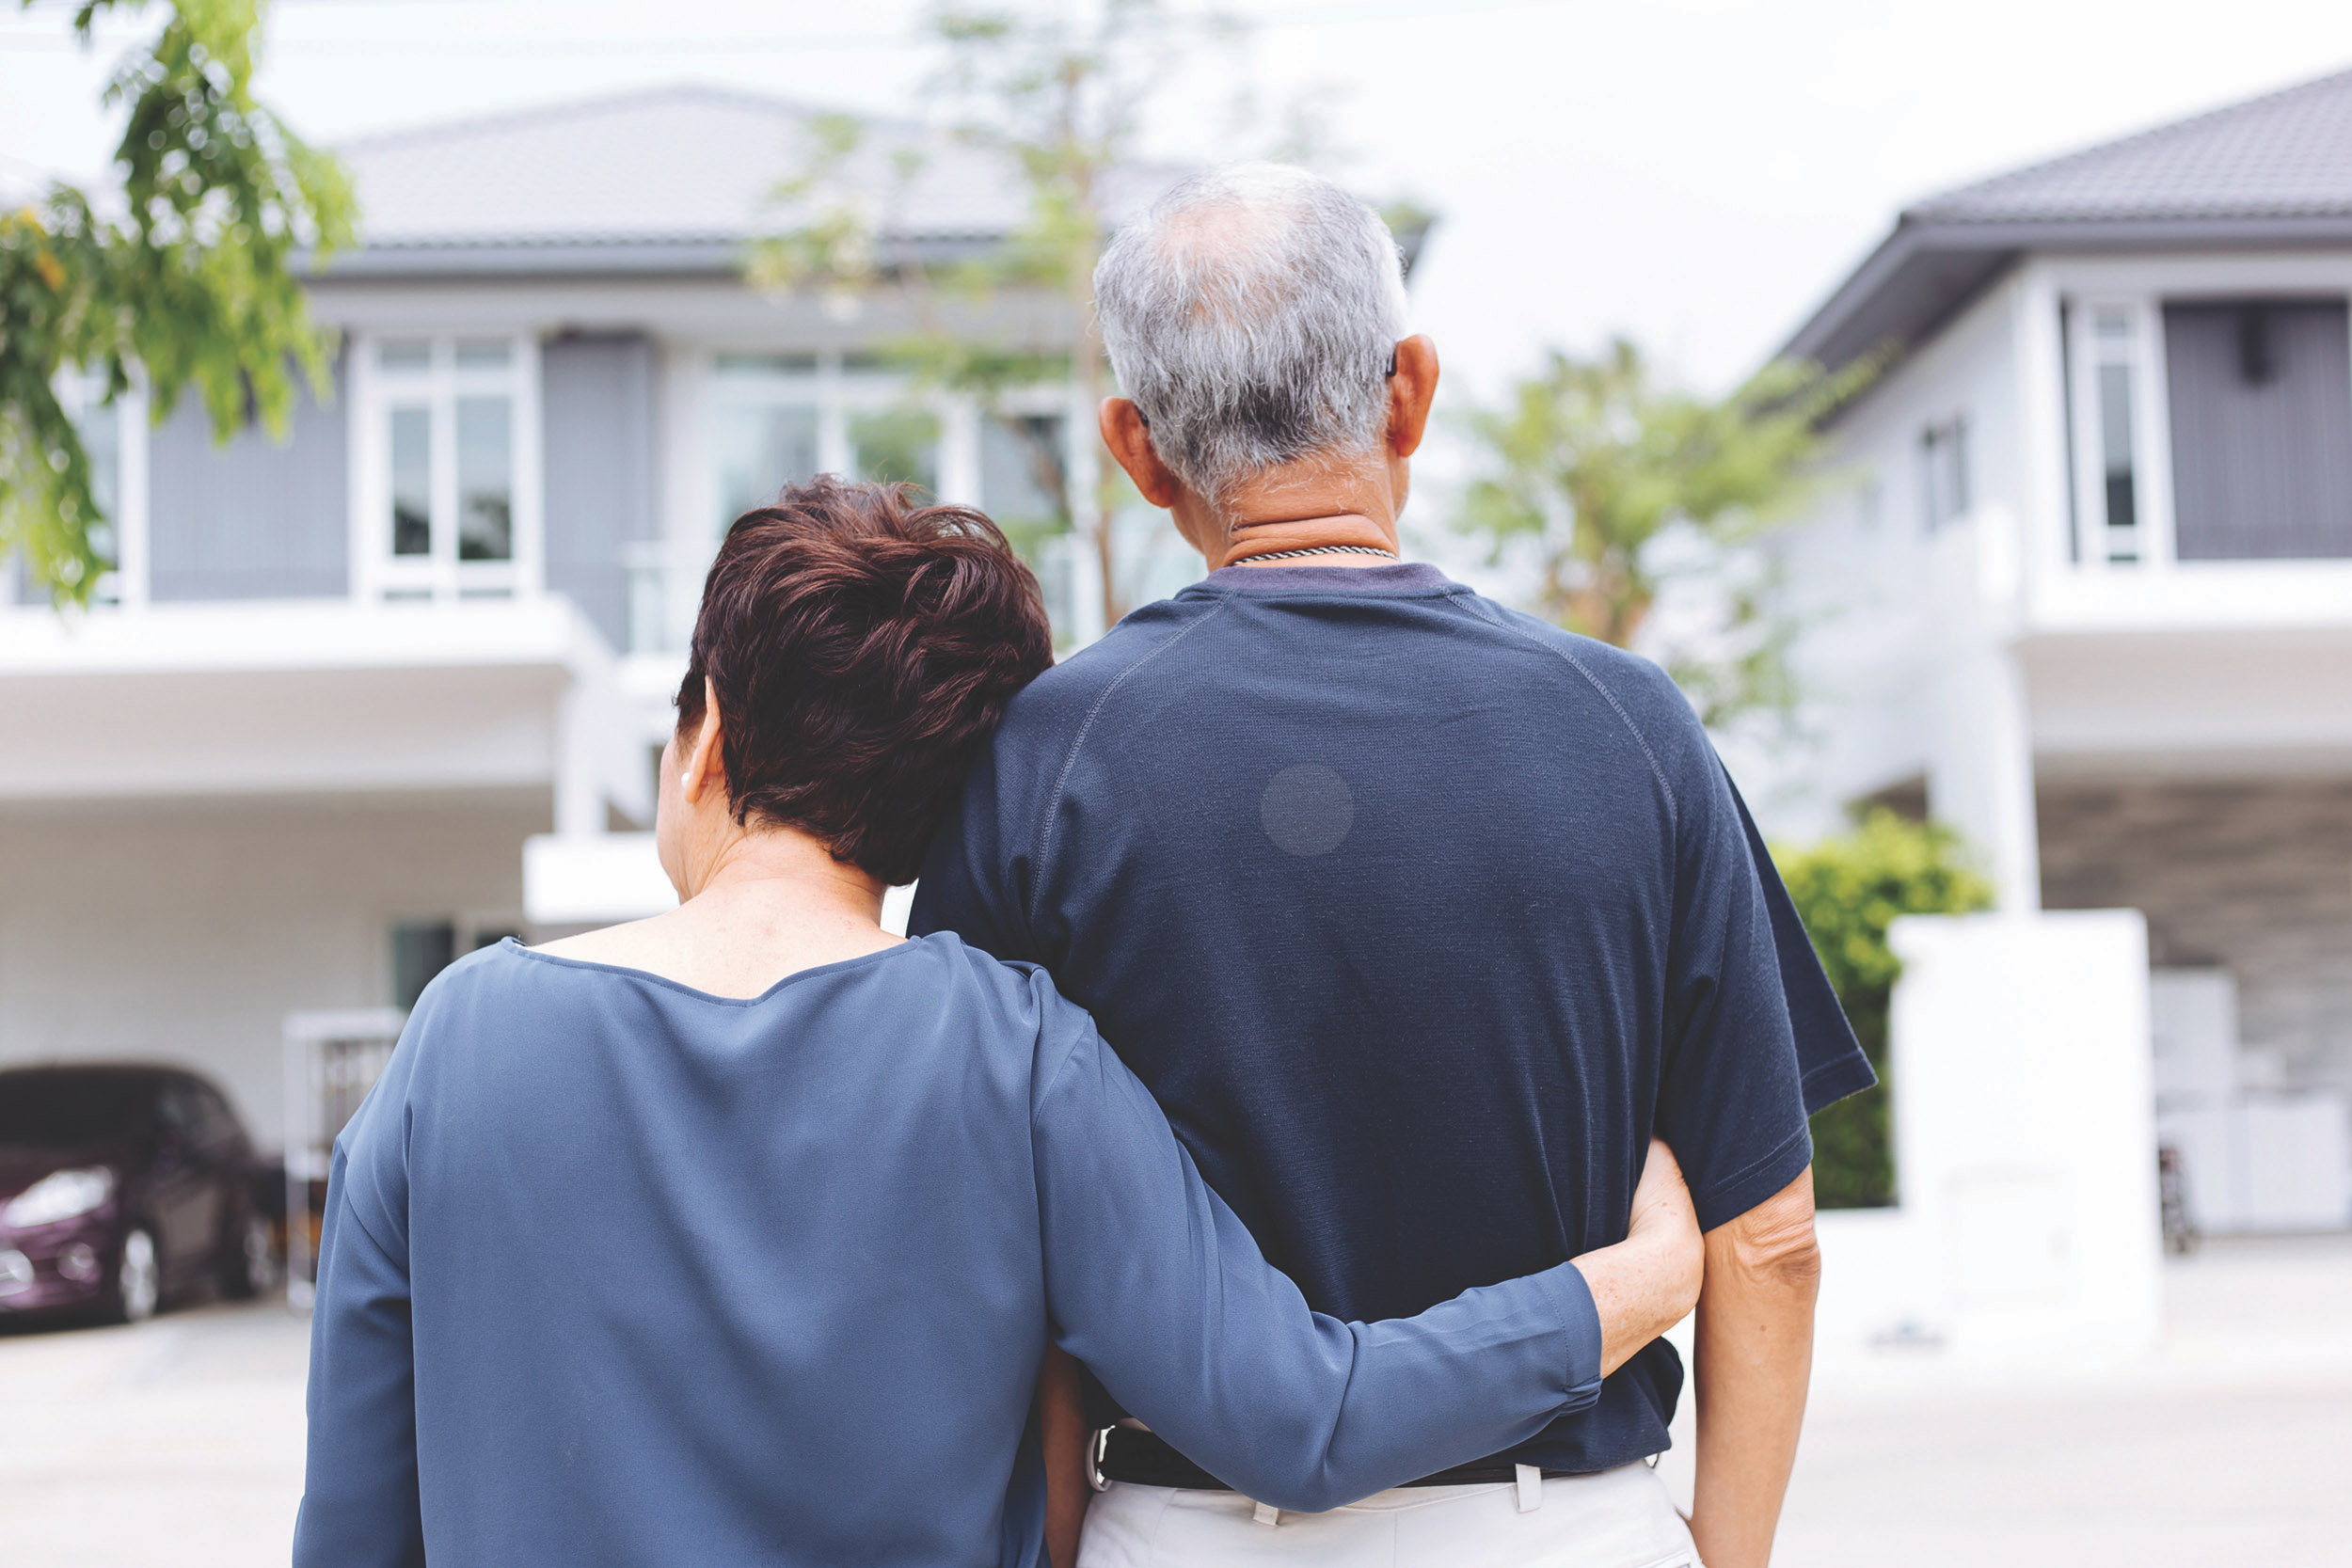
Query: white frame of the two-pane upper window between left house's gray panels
xmin=348 ymin=326 xmax=546 ymax=604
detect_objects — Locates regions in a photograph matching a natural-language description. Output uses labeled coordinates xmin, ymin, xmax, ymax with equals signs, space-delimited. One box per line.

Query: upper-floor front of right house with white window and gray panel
xmin=2021 ymin=256 xmax=2352 ymax=632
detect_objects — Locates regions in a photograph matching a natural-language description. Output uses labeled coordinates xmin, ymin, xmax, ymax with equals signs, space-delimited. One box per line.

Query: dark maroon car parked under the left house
xmin=0 ymin=1065 xmax=276 ymax=1323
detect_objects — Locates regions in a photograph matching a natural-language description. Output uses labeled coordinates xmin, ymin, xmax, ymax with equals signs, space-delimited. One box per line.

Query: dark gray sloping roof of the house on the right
xmin=1783 ymin=71 xmax=2352 ymax=367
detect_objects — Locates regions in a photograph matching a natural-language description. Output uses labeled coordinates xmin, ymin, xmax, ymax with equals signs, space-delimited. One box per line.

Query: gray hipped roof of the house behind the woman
xmin=329 ymin=87 xmax=1176 ymax=275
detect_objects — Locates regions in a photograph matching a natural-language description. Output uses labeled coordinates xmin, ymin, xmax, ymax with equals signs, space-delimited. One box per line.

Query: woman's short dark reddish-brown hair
xmin=677 ymin=475 xmax=1054 ymax=884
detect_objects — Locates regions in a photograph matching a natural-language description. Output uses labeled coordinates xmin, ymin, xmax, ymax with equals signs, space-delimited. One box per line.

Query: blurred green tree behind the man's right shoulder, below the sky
xmin=1456 ymin=339 xmax=1877 ymax=724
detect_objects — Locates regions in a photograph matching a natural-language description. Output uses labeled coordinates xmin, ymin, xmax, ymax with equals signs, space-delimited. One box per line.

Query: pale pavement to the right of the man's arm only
xmin=1773 ymin=1237 xmax=2352 ymax=1568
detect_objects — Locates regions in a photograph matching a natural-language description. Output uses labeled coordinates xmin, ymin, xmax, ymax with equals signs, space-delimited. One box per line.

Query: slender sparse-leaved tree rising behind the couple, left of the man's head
xmin=748 ymin=0 xmax=1392 ymax=626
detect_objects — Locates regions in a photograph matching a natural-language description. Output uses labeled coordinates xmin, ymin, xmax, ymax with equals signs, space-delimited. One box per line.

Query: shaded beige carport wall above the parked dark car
xmin=0 ymin=790 xmax=550 ymax=1149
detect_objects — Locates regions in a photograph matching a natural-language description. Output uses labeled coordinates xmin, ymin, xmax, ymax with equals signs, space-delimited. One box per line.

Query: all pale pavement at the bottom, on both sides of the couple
xmin=0 ymin=1237 xmax=2352 ymax=1568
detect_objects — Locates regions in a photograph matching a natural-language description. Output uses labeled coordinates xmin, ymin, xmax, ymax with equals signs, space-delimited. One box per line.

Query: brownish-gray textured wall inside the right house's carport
xmin=2040 ymin=778 xmax=2352 ymax=1091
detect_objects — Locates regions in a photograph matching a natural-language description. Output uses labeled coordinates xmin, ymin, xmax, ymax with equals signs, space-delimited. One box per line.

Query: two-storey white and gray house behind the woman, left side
xmin=0 ymin=89 xmax=1200 ymax=1148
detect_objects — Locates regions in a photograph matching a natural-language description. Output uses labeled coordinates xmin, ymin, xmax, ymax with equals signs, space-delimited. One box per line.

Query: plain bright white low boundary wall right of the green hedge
xmin=1819 ymin=910 xmax=2159 ymax=1359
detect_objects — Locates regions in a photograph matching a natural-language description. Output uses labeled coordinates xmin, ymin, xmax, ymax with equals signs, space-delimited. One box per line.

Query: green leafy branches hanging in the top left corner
xmin=0 ymin=0 xmax=353 ymax=604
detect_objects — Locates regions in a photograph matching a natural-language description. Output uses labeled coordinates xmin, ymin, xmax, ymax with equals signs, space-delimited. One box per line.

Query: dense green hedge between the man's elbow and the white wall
xmin=1773 ymin=809 xmax=1993 ymax=1209
